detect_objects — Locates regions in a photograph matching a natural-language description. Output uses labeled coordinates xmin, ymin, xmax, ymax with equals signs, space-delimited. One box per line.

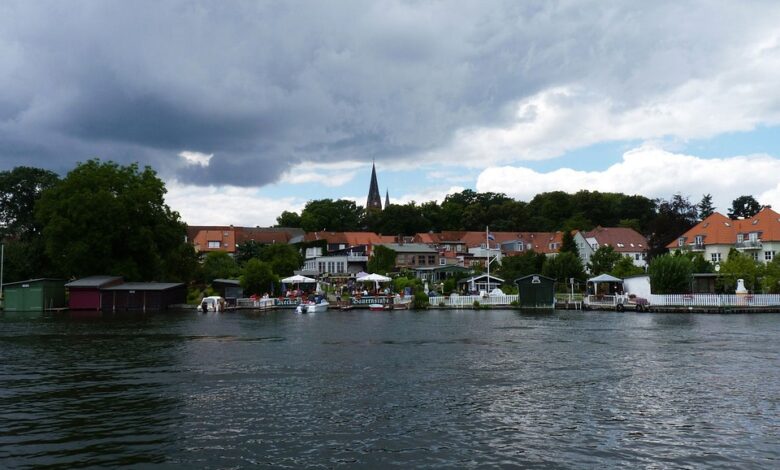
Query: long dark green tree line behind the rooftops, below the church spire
xmin=276 ymin=189 xmax=761 ymax=257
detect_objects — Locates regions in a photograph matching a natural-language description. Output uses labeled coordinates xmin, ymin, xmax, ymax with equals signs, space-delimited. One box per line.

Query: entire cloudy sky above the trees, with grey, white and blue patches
xmin=0 ymin=0 xmax=780 ymax=225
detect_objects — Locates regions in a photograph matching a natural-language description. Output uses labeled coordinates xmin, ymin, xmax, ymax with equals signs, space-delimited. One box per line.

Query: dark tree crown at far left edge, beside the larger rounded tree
xmin=0 ymin=166 xmax=59 ymax=241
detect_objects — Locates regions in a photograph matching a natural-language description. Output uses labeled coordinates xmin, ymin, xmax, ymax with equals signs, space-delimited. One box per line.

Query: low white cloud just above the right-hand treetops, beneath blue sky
xmin=477 ymin=146 xmax=780 ymax=213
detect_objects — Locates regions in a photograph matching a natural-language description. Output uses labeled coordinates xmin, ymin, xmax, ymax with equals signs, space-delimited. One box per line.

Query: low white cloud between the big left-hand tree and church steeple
xmin=165 ymin=181 xmax=305 ymax=227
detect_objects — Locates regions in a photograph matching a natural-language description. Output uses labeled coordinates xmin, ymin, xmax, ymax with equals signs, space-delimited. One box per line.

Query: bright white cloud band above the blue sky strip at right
xmin=425 ymin=27 xmax=780 ymax=168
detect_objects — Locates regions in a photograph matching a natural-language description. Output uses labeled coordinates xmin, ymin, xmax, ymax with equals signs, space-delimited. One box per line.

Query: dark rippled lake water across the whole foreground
xmin=0 ymin=310 xmax=780 ymax=468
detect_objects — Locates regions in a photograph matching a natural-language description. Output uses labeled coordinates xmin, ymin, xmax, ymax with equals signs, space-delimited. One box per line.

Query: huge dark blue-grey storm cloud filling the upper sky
xmin=0 ymin=1 xmax=776 ymax=185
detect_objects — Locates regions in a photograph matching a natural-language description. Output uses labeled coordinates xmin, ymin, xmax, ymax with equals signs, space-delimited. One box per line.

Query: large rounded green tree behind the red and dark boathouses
xmin=35 ymin=160 xmax=186 ymax=281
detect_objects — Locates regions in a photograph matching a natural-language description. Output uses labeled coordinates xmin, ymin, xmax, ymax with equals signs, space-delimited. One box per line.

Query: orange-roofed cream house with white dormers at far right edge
xmin=667 ymin=207 xmax=780 ymax=264
